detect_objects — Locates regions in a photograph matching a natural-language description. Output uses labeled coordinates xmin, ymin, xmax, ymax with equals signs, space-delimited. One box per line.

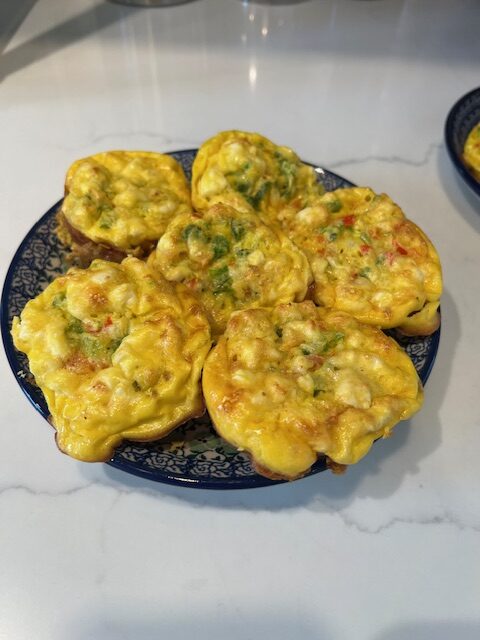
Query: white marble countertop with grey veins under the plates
xmin=0 ymin=0 xmax=480 ymax=640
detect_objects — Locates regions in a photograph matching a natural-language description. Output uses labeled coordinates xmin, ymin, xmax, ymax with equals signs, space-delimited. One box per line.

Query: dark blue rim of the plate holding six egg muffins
xmin=0 ymin=148 xmax=441 ymax=490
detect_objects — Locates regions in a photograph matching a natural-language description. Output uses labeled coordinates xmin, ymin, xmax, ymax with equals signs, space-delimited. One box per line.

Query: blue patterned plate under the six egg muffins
xmin=1 ymin=149 xmax=440 ymax=489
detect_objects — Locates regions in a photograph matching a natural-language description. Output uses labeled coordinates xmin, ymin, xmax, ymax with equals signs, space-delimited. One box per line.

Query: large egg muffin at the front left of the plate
xmin=12 ymin=257 xmax=211 ymax=462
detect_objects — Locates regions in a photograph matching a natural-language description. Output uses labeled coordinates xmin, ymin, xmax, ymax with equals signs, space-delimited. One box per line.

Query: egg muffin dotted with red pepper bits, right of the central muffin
xmin=284 ymin=187 xmax=442 ymax=335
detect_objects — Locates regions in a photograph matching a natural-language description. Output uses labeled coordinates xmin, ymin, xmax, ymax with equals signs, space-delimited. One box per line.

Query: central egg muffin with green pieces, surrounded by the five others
xmin=149 ymin=204 xmax=312 ymax=336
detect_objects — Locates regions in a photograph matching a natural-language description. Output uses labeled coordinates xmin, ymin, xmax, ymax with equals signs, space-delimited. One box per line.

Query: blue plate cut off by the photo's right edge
xmin=445 ymin=87 xmax=480 ymax=197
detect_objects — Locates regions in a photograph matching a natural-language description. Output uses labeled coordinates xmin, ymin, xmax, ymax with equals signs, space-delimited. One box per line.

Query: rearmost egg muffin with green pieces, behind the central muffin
xmin=192 ymin=131 xmax=323 ymax=221
